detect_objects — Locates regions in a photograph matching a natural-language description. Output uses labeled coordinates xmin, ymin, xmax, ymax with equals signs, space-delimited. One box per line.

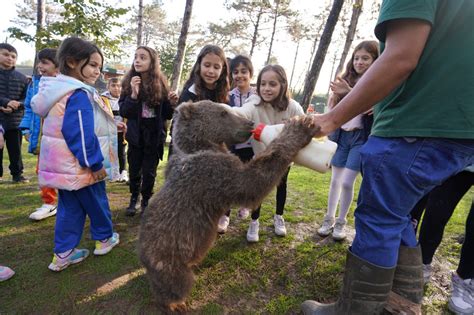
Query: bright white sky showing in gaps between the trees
xmin=0 ymin=0 xmax=374 ymax=94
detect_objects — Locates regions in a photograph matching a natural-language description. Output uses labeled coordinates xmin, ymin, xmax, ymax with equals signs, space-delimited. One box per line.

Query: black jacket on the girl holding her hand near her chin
xmin=119 ymin=94 xmax=173 ymax=159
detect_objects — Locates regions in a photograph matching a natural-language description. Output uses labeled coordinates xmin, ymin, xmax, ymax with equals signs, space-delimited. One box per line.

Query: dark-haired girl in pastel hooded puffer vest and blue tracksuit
xmin=31 ymin=37 xmax=119 ymax=271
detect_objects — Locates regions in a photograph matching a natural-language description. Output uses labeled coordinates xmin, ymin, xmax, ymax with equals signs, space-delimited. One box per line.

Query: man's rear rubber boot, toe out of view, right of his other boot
xmin=392 ymin=245 xmax=423 ymax=304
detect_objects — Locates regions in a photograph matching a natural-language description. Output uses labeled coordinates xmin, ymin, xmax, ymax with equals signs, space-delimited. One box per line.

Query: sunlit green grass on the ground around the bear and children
xmin=0 ymin=146 xmax=472 ymax=314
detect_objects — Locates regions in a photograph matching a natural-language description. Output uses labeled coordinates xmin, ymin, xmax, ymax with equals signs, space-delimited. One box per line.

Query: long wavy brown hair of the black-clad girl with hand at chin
xmin=122 ymin=46 xmax=169 ymax=107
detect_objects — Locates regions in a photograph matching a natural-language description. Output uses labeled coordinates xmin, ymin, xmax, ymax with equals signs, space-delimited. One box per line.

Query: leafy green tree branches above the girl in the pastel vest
xmin=8 ymin=0 xmax=128 ymax=57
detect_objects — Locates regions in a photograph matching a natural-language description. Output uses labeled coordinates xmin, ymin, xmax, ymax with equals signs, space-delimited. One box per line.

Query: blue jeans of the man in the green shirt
xmin=351 ymin=136 xmax=474 ymax=268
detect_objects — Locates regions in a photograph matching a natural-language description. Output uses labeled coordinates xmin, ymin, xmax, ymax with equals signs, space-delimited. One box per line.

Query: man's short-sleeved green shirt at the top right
xmin=372 ymin=0 xmax=474 ymax=139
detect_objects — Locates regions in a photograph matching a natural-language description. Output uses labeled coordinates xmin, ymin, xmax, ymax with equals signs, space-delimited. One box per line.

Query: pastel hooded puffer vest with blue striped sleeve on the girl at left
xmin=31 ymin=75 xmax=118 ymax=190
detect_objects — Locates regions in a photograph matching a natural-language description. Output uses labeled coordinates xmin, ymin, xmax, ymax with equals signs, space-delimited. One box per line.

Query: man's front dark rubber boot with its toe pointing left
xmin=301 ymin=250 xmax=395 ymax=315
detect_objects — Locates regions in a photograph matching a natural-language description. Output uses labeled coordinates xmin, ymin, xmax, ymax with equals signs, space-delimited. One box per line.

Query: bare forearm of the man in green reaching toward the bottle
xmin=314 ymin=19 xmax=431 ymax=136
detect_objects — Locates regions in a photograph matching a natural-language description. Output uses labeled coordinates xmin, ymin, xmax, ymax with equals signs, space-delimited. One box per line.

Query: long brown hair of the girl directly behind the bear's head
xmin=184 ymin=45 xmax=229 ymax=103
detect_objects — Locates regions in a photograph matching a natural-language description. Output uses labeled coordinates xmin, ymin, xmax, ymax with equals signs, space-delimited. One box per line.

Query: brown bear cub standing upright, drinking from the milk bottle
xmin=139 ymin=101 xmax=318 ymax=313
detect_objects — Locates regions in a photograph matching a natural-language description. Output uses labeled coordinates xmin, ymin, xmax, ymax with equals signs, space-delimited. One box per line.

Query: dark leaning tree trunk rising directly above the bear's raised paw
xmin=301 ymin=0 xmax=344 ymax=106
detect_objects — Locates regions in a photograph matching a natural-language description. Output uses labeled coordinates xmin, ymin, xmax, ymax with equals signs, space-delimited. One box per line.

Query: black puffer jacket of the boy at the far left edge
xmin=0 ymin=68 xmax=28 ymax=131
